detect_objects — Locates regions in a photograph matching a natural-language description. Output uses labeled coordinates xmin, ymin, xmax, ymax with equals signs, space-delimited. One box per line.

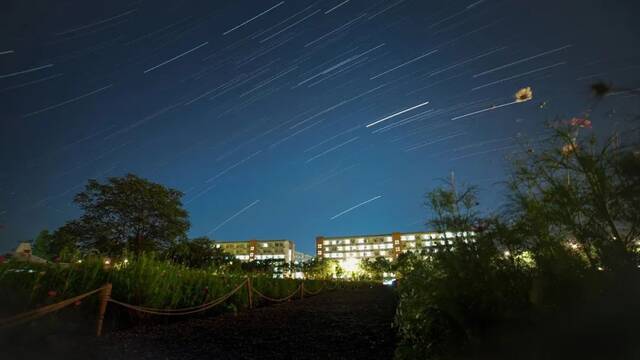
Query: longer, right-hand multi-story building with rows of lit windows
xmin=316 ymin=231 xmax=475 ymax=261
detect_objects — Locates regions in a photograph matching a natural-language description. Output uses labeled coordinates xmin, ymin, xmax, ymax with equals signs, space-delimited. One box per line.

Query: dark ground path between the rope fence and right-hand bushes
xmin=101 ymin=288 xmax=396 ymax=360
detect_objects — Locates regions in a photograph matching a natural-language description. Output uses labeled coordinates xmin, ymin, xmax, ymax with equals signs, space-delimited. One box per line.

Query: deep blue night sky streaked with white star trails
xmin=0 ymin=0 xmax=640 ymax=253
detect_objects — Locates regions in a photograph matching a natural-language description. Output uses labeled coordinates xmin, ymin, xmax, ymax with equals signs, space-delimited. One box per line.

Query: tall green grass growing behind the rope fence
xmin=0 ymin=255 xmax=360 ymax=315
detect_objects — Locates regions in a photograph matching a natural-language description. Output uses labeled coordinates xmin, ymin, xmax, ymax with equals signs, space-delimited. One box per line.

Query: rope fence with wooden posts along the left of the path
xmin=0 ymin=277 xmax=338 ymax=336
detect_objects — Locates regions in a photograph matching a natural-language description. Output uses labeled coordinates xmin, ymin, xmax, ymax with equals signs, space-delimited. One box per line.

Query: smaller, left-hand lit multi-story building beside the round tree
xmin=216 ymin=240 xmax=295 ymax=263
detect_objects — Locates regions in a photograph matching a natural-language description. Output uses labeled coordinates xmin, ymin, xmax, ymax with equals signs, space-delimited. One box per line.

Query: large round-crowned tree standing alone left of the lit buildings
xmin=71 ymin=174 xmax=189 ymax=256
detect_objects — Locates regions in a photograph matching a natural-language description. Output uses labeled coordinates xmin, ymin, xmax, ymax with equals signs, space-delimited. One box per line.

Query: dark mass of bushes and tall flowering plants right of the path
xmin=395 ymin=123 xmax=640 ymax=359
